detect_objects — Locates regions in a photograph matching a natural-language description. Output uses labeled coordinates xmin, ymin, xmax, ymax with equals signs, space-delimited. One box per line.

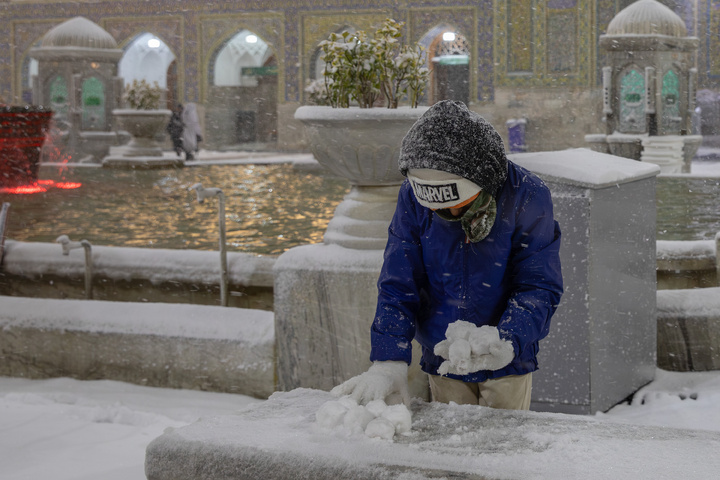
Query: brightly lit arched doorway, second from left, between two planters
xmin=206 ymin=29 xmax=278 ymax=150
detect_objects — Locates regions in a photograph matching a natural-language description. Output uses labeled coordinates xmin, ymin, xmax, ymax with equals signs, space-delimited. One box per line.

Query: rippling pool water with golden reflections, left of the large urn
xmin=0 ymin=164 xmax=349 ymax=255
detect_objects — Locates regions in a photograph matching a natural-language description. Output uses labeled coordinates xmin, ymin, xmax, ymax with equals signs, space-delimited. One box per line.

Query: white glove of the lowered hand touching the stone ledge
xmin=330 ymin=361 xmax=410 ymax=406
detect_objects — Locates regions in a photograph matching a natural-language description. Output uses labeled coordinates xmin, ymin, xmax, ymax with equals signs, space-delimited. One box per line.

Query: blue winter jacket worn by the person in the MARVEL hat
xmin=370 ymin=162 xmax=563 ymax=382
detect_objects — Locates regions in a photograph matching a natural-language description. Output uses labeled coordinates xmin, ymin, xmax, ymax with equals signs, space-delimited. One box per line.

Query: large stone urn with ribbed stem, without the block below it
xmin=295 ymin=106 xmax=428 ymax=250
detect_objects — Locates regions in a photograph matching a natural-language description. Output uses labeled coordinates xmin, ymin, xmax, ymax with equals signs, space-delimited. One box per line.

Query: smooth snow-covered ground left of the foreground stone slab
xmin=0 ymin=377 xmax=260 ymax=480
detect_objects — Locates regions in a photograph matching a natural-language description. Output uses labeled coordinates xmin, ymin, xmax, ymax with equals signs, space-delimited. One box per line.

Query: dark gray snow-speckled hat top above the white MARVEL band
xmin=398 ymin=100 xmax=508 ymax=196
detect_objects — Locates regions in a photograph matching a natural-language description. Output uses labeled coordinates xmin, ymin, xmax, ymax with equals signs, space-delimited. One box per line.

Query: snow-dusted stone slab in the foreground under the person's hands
xmin=145 ymin=389 xmax=720 ymax=480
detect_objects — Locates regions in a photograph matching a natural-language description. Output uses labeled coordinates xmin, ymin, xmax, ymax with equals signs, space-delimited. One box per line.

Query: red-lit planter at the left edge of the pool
xmin=0 ymin=107 xmax=53 ymax=188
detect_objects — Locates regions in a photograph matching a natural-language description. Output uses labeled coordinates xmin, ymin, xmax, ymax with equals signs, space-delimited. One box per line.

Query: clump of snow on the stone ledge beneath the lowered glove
xmin=315 ymin=396 xmax=412 ymax=441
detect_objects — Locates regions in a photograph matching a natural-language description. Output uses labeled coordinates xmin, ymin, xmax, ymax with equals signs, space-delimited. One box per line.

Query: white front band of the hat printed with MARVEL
xmin=407 ymin=168 xmax=480 ymax=210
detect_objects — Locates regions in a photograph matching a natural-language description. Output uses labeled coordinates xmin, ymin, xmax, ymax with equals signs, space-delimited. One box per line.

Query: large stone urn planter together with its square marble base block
xmin=273 ymin=107 xmax=428 ymax=398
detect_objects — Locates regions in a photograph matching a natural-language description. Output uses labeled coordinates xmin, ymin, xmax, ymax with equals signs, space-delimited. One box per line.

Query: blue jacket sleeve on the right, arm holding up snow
xmin=498 ymin=182 xmax=563 ymax=356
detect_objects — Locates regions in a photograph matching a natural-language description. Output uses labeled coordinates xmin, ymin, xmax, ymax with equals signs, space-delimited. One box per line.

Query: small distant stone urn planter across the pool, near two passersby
xmin=113 ymin=109 xmax=172 ymax=157
